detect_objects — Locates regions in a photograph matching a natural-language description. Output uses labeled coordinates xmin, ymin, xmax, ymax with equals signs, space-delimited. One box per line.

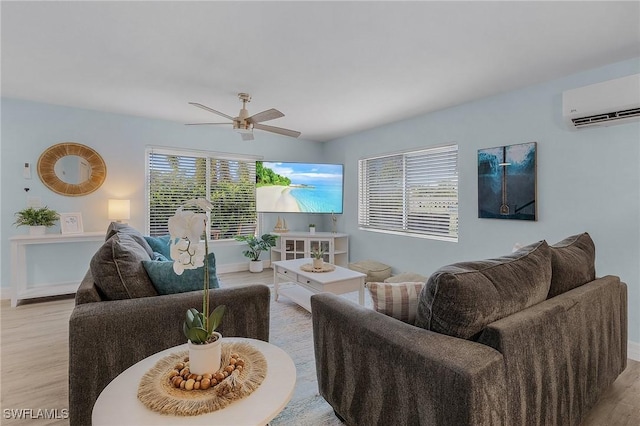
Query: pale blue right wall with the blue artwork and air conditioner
xmin=325 ymin=59 xmax=640 ymax=342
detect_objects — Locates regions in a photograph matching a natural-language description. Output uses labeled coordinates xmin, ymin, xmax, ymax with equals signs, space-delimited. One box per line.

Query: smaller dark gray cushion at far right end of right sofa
xmin=548 ymin=232 xmax=596 ymax=297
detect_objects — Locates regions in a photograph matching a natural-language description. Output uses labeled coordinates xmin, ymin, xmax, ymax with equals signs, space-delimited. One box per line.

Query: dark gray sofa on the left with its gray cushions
xmin=69 ymin=224 xmax=270 ymax=426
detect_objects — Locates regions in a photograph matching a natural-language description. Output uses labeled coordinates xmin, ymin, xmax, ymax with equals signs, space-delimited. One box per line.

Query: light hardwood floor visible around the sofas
xmin=0 ymin=269 xmax=640 ymax=426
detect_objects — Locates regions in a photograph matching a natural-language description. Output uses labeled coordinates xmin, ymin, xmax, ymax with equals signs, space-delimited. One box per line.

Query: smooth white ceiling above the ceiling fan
xmin=0 ymin=1 xmax=640 ymax=141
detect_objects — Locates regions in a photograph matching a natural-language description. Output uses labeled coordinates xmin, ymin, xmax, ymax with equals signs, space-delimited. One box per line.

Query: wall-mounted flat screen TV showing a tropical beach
xmin=256 ymin=161 xmax=344 ymax=214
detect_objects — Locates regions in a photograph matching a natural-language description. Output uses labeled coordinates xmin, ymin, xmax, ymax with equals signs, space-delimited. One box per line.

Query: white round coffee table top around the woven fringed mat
xmin=91 ymin=337 xmax=296 ymax=426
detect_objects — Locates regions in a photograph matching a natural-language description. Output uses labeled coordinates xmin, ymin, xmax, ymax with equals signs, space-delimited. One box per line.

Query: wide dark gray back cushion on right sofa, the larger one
xmin=416 ymin=241 xmax=551 ymax=340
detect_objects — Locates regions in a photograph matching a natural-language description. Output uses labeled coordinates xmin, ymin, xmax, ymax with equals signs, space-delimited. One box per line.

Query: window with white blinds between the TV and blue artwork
xmin=358 ymin=145 xmax=458 ymax=241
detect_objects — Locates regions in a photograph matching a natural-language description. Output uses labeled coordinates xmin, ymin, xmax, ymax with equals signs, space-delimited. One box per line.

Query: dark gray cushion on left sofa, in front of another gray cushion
xmin=90 ymin=233 xmax=158 ymax=300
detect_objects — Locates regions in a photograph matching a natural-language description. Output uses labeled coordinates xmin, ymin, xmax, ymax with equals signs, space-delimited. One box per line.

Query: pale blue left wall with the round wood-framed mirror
xmin=0 ymin=98 xmax=322 ymax=288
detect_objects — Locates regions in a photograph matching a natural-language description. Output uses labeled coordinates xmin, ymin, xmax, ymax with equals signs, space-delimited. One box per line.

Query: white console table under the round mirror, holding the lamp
xmin=9 ymin=232 xmax=105 ymax=307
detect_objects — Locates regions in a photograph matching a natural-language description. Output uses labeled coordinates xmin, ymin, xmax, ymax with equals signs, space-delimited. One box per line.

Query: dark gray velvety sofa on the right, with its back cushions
xmin=311 ymin=233 xmax=627 ymax=426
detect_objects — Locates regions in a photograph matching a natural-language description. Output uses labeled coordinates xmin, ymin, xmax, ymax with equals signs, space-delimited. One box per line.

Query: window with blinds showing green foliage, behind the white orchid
xmin=147 ymin=148 xmax=258 ymax=240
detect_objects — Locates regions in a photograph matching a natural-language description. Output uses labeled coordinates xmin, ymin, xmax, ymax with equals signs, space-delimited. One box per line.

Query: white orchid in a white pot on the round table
xmin=168 ymin=198 xmax=225 ymax=374
